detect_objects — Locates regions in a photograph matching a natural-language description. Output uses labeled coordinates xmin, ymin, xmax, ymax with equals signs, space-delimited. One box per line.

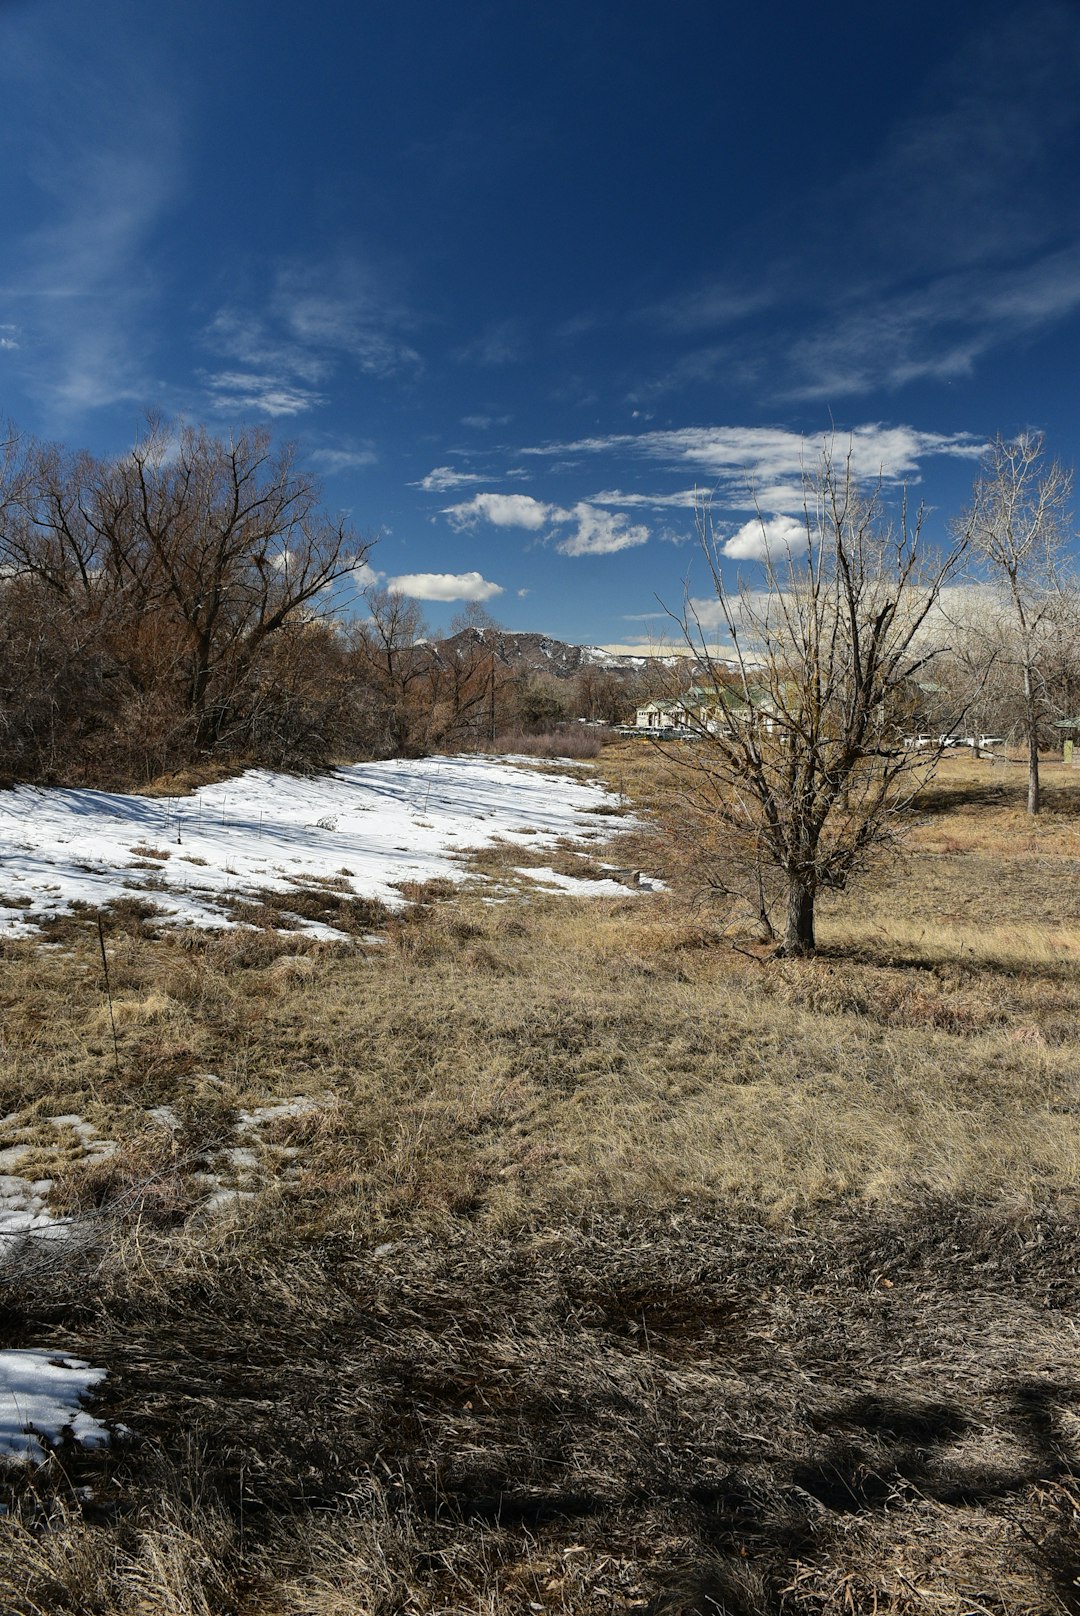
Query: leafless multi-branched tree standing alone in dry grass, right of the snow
xmin=669 ymin=449 xmax=964 ymax=955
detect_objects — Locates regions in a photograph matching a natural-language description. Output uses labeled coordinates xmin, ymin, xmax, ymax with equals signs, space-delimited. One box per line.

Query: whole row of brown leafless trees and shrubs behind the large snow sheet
xmin=0 ymin=423 xmax=632 ymax=787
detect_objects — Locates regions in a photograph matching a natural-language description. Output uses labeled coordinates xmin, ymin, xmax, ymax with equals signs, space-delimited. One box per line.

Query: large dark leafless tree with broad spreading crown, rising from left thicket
xmin=0 ymin=422 xmax=370 ymax=753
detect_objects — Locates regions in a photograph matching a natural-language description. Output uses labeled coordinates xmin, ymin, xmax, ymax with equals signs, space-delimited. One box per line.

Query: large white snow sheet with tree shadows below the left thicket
xmin=0 ymin=756 xmax=627 ymax=937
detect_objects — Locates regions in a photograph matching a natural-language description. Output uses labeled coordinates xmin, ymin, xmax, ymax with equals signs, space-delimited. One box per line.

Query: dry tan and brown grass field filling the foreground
xmin=0 ymin=743 xmax=1080 ymax=1616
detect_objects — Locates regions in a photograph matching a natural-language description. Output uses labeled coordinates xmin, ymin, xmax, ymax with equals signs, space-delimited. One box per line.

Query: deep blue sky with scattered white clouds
xmin=0 ymin=0 xmax=1080 ymax=645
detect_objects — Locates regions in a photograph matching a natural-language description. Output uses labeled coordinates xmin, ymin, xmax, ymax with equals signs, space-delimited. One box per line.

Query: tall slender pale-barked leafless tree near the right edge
xmin=956 ymin=433 xmax=1072 ymax=814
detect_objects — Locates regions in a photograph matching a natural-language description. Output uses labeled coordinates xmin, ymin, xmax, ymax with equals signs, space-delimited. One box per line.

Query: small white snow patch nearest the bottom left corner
xmin=0 ymin=1348 xmax=108 ymax=1464
